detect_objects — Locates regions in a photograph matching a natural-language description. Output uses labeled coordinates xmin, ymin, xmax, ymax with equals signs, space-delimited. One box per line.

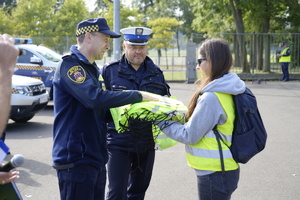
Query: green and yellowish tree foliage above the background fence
xmin=0 ymin=0 xmax=300 ymax=59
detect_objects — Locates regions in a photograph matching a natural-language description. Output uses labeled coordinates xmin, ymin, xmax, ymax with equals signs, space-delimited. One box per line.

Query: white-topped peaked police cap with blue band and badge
xmin=120 ymin=27 xmax=152 ymax=46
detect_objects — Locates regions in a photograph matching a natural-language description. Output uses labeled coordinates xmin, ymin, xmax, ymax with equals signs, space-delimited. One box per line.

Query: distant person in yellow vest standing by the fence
xmin=277 ymin=42 xmax=291 ymax=81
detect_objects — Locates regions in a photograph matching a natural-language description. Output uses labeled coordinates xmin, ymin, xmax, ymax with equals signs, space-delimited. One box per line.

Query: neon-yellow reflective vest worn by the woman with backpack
xmin=185 ymin=92 xmax=238 ymax=171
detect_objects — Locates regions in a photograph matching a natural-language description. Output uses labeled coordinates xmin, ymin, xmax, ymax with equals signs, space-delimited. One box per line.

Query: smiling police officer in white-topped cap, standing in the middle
xmin=102 ymin=27 xmax=170 ymax=200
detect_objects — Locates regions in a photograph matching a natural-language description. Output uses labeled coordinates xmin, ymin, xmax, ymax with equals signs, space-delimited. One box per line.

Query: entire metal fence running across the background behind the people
xmin=32 ymin=33 xmax=300 ymax=81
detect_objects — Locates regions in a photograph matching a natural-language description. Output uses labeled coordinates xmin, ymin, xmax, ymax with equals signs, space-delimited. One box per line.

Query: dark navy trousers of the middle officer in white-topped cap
xmin=106 ymin=148 xmax=155 ymax=200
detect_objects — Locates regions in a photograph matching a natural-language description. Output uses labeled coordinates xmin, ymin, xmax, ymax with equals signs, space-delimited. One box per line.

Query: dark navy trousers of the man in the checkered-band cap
xmin=57 ymin=165 xmax=106 ymax=200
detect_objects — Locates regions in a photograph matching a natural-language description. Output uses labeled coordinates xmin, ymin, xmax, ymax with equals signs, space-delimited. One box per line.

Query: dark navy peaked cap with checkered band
xmin=76 ymin=18 xmax=121 ymax=38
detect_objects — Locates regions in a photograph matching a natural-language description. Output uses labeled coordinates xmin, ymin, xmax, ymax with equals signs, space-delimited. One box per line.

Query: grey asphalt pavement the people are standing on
xmin=6 ymin=81 xmax=300 ymax=200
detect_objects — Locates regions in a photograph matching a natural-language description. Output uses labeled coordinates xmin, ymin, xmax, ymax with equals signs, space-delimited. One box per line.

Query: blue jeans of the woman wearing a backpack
xmin=197 ymin=168 xmax=240 ymax=200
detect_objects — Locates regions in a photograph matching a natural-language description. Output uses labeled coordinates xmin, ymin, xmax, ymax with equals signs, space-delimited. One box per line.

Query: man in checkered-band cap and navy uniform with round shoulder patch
xmin=52 ymin=18 xmax=155 ymax=200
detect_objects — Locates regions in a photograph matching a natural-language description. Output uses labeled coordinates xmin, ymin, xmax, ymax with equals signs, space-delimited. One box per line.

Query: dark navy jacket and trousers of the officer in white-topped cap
xmin=102 ymin=55 xmax=170 ymax=200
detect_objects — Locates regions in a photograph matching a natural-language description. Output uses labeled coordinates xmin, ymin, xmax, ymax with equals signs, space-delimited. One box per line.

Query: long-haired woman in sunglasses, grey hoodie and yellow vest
xmin=155 ymin=38 xmax=246 ymax=200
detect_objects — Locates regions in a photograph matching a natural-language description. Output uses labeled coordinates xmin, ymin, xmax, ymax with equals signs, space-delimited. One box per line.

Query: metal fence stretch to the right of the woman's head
xmin=204 ymin=33 xmax=300 ymax=74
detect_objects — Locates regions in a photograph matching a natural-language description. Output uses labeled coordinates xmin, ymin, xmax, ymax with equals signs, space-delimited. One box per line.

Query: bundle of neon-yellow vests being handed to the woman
xmin=110 ymin=93 xmax=187 ymax=150
